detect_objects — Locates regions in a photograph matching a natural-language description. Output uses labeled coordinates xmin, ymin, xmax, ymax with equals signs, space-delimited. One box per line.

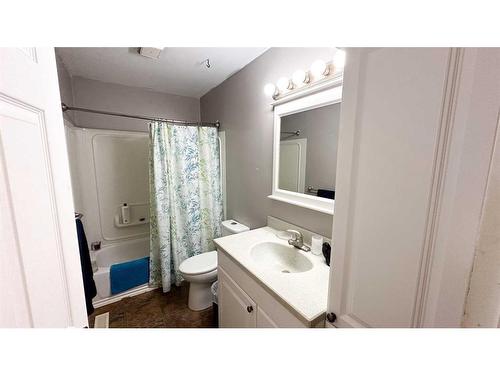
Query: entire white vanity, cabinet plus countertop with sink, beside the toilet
xmin=215 ymin=227 xmax=329 ymax=327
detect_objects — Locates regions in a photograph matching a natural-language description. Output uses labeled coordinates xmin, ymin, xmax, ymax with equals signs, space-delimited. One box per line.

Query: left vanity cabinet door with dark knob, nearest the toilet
xmin=218 ymin=267 xmax=257 ymax=328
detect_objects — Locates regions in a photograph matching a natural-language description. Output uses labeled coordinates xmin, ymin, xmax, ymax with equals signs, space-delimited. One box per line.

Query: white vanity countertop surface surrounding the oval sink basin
xmin=214 ymin=227 xmax=330 ymax=322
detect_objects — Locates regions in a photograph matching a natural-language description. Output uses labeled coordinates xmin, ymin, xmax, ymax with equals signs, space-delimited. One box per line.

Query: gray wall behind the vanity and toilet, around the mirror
xmin=201 ymin=48 xmax=333 ymax=237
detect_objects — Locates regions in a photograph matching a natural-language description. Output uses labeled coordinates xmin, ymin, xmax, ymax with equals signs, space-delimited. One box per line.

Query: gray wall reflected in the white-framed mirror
xmin=281 ymin=104 xmax=340 ymax=190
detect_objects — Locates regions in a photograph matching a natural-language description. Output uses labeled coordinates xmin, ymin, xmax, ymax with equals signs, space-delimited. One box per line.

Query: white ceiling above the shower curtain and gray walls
xmin=56 ymin=47 xmax=267 ymax=98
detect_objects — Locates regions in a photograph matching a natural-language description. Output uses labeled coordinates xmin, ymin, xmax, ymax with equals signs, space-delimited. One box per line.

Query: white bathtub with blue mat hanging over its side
xmin=91 ymin=237 xmax=149 ymax=306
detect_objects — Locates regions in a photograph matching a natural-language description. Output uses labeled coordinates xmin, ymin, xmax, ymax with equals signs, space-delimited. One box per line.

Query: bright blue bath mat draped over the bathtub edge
xmin=109 ymin=257 xmax=149 ymax=294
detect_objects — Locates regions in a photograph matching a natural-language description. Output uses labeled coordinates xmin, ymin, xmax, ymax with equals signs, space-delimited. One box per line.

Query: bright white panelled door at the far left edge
xmin=0 ymin=48 xmax=88 ymax=327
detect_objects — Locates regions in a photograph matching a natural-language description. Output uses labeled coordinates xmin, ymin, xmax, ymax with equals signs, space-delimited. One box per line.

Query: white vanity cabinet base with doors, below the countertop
xmin=218 ymin=249 xmax=324 ymax=328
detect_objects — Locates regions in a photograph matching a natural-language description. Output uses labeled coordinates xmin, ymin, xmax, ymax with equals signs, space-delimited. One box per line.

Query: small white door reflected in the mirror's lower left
xmin=278 ymin=138 xmax=307 ymax=193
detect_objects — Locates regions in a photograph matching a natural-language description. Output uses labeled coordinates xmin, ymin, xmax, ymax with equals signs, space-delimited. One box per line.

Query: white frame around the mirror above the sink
xmin=268 ymin=79 xmax=342 ymax=215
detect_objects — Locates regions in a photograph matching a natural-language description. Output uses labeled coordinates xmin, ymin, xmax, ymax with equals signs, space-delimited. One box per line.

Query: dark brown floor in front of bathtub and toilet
xmin=89 ymin=284 xmax=214 ymax=328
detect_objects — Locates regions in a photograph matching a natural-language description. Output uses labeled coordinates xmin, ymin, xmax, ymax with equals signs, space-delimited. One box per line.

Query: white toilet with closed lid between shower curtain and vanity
xmin=179 ymin=220 xmax=250 ymax=311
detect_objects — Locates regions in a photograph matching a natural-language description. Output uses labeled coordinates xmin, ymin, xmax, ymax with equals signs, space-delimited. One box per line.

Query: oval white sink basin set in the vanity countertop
xmin=250 ymin=242 xmax=313 ymax=274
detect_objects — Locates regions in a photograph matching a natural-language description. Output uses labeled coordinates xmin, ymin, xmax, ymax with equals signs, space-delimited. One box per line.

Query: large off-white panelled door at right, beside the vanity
xmin=327 ymin=48 xmax=498 ymax=327
